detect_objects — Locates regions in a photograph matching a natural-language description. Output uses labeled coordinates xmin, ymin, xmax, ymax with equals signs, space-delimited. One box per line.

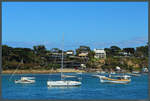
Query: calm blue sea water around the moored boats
xmin=2 ymin=73 xmax=148 ymax=99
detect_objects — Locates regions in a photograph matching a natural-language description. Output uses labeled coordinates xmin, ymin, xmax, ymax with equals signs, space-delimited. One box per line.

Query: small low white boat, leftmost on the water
xmin=15 ymin=77 xmax=35 ymax=83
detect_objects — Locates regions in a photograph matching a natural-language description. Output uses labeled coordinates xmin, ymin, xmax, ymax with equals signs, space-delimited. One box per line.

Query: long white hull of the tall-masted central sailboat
xmin=47 ymin=81 xmax=81 ymax=87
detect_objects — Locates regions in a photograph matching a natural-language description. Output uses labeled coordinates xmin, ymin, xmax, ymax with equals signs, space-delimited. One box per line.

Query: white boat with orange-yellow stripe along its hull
xmin=99 ymin=75 xmax=131 ymax=84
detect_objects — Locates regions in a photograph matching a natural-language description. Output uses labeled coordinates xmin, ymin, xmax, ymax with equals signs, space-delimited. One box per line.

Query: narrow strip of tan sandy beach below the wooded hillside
xmin=1 ymin=69 xmax=86 ymax=74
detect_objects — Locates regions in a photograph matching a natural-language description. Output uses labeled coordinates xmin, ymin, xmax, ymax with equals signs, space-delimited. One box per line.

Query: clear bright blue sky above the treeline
xmin=2 ymin=2 xmax=148 ymax=49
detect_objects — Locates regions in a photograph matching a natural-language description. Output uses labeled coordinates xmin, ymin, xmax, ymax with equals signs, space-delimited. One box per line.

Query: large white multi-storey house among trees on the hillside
xmin=94 ymin=49 xmax=106 ymax=59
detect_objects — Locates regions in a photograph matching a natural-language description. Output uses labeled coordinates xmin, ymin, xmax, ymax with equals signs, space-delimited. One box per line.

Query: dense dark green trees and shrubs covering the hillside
xmin=2 ymin=45 xmax=148 ymax=70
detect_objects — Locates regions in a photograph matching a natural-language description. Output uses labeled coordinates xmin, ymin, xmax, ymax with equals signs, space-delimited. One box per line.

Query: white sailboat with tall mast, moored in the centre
xmin=47 ymin=33 xmax=82 ymax=87
